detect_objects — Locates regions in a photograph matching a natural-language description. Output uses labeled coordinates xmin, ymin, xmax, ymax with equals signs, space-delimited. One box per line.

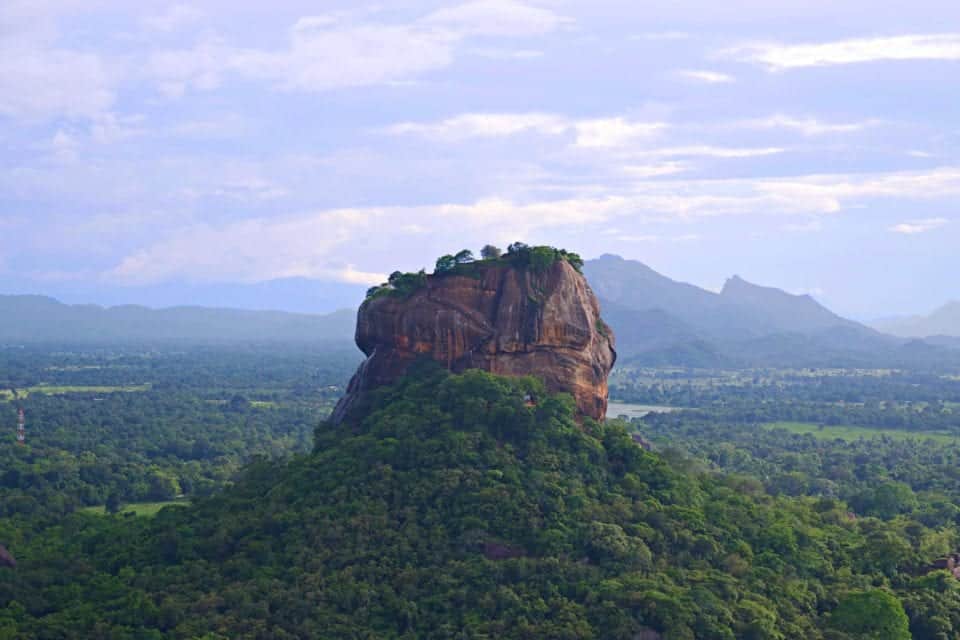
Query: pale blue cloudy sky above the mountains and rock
xmin=0 ymin=0 xmax=960 ymax=319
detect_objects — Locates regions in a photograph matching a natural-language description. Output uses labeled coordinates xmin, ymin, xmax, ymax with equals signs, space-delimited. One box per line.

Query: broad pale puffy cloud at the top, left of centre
xmin=149 ymin=0 xmax=569 ymax=97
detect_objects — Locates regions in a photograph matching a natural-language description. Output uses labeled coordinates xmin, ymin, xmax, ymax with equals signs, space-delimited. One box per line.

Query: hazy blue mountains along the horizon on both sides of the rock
xmin=0 ymin=255 xmax=960 ymax=368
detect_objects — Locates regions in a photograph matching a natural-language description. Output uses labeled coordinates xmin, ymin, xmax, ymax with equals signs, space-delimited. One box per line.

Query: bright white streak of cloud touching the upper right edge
xmin=721 ymin=33 xmax=960 ymax=71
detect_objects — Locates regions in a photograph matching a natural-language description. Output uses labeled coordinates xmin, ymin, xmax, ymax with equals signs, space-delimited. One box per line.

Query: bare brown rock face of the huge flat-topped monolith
xmin=331 ymin=260 xmax=616 ymax=422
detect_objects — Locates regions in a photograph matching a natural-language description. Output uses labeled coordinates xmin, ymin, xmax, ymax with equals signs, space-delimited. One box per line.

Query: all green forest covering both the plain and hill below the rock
xmin=0 ymin=345 xmax=960 ymax=640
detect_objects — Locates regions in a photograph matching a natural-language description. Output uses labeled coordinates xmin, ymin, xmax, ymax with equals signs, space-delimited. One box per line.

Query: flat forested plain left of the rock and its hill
xmin=0 ymin=347 xmax=356 ymax=528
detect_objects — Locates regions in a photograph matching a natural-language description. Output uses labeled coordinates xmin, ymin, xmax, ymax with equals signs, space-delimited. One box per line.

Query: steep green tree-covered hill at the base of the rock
xmin=0 ymin=369 xmax=936 ymax=640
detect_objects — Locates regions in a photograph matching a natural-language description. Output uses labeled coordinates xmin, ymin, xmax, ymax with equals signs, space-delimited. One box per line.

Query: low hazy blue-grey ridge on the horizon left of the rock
xmin=0 ymin=295 xmax=356 ymax=344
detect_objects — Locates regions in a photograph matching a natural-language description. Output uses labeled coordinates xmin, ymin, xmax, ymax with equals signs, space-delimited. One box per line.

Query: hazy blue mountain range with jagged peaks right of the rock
xmin=584 ymin=255 xmax=960 ymax=367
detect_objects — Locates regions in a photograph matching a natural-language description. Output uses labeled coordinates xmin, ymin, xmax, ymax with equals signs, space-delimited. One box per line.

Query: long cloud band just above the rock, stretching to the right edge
xmin=106 ymin=169 xmax=960 ymax=283
